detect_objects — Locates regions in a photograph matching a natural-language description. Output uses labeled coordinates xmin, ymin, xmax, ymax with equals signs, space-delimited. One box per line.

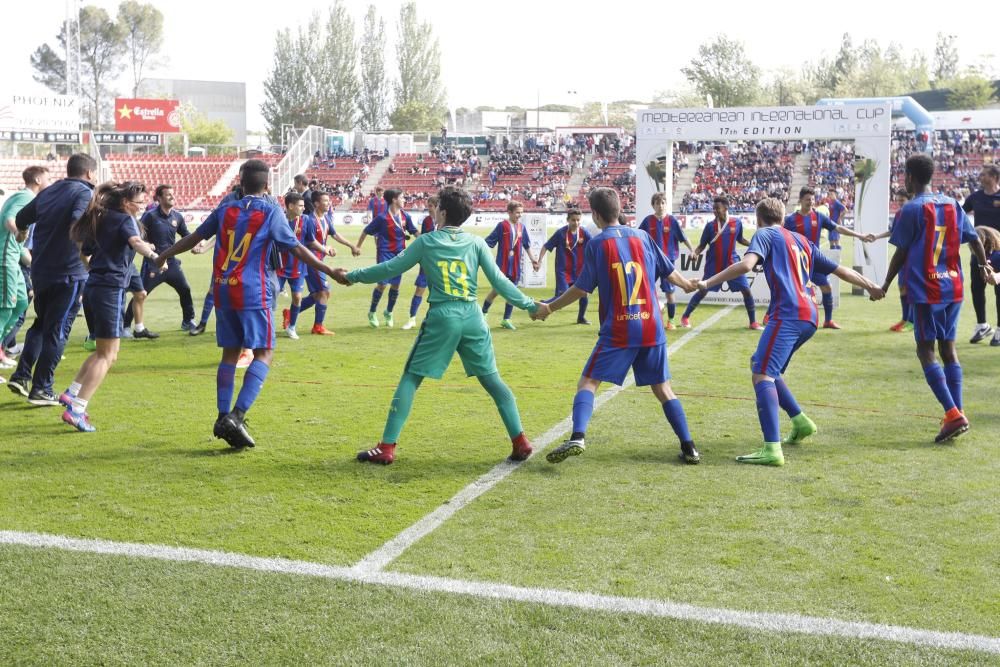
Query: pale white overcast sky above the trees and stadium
xmin=7 ymin=0 xmax=995 ymax=132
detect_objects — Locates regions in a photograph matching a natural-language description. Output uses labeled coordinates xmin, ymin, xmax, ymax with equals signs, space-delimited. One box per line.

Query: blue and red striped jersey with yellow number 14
xmin=198 ymin=195 xmax=299 ymax=310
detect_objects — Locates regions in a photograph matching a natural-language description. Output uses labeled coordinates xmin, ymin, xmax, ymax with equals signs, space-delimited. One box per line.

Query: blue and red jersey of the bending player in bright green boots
xmin=747 ymin=225 xmax=837 ymax=326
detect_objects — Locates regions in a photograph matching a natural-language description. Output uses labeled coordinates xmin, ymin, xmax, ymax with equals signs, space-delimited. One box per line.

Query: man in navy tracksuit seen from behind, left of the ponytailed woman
xmin=7 ymin=153 xmax=97 ymax=405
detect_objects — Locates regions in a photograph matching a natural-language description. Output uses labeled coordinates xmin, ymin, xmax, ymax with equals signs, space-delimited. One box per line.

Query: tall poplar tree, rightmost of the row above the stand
xmin=393 ymin=1 xmax=447 ymax=122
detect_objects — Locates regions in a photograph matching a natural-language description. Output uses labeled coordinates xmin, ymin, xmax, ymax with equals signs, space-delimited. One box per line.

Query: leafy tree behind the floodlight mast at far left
xmin=30 ymin=5 xmax=125 ymax=130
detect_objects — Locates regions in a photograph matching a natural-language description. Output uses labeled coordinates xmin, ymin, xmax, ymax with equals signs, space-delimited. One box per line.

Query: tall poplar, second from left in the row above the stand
xmin=318 ymin=0 xmax=361 ymax=130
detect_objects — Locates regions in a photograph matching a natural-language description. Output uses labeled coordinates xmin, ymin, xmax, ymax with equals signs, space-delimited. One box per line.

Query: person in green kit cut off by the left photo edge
xmin=0 ymin=166 xmax=49 ymax=374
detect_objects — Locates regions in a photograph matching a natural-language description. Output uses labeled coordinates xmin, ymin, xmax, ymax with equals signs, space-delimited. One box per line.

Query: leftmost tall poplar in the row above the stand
xmin=260 ymin=28 xmax=319 ymax=144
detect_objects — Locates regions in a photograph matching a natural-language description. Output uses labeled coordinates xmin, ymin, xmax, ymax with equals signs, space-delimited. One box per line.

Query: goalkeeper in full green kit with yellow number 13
xmin=333 ymin=186 xmax=538 ymax=464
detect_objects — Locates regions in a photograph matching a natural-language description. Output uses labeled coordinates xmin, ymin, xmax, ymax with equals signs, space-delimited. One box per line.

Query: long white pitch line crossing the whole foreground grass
xmin=0 ymin=531 xmax=1000 ymax=655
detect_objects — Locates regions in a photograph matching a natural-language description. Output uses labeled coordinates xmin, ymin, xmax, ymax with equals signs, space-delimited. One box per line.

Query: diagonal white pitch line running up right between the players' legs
xmin=354 ymin=306 xmax=735 ymax=572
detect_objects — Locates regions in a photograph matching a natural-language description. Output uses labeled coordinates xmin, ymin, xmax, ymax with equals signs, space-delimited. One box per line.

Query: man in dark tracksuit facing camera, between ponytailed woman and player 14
xmin=125 ymin=185 xmax=196 ymax=331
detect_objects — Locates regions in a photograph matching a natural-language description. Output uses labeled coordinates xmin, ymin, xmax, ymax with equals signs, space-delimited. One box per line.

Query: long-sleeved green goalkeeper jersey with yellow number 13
xmin=347 ymin=227 xmax=536 ymax=312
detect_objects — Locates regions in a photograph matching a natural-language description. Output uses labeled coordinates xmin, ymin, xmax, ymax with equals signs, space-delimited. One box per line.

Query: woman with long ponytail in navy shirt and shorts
xmin=59 ymin=181 xmax=156 ymax=431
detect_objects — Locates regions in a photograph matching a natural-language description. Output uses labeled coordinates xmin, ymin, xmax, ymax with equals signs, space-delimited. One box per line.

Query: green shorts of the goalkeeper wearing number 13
xmin=405 ymin=301 xmax=497 ymax=380
